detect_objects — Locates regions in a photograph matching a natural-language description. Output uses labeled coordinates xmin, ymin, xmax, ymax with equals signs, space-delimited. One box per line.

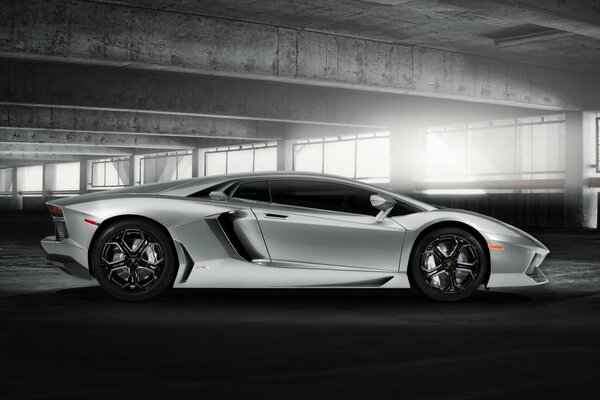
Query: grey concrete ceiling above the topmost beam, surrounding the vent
xmin=94 ymin=0 xmax=600 ymax=73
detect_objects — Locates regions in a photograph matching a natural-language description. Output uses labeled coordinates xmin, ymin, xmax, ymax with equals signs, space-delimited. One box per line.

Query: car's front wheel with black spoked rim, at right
xmin=409 ymin=227 xmax=489 ymax=302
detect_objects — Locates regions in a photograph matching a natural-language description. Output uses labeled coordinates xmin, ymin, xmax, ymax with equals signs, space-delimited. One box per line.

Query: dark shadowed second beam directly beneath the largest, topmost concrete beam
xmin=0 ymin=59 xmax=564 ymax=129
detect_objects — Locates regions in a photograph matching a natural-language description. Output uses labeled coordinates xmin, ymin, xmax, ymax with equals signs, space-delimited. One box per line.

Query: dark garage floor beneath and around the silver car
xmin=0 ymin=213 xmax=600 ymax=399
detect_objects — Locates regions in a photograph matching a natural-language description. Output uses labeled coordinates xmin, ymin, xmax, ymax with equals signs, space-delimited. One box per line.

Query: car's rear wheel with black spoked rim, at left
xmin=91 ymin=219 xmax=177 ymax=301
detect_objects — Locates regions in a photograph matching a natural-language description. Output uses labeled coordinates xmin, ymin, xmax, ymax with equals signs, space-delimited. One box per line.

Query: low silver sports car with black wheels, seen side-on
xmin=42 ymin=172 xmax=548 ymax=301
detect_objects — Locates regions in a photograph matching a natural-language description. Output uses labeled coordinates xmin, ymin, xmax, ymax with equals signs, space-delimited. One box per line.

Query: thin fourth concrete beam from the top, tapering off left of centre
xmin=0 ymin=128 xmax=245 ymax=153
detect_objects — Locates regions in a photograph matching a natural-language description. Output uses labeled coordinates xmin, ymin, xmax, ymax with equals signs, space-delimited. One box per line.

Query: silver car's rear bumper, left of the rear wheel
xmin=40 ymin=236 xmax=91 ymax=279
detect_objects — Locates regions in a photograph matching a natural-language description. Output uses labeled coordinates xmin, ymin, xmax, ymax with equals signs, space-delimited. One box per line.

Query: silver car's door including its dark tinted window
xmin=252 ymin=179 xmax=405 ymax=272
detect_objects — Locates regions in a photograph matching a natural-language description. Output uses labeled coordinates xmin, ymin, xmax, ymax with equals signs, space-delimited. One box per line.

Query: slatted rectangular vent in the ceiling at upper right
xmin=482 ymin=24 xmax=573 ymax=48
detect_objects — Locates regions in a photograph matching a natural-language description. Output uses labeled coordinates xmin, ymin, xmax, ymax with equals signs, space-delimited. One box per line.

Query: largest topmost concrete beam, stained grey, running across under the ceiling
xmin=0 ymin=0 xmax=586 ymax=109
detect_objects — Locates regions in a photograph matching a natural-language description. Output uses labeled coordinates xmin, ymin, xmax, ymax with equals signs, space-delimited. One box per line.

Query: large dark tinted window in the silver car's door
xmin=269 ymin=180 xmax=378 ymax=216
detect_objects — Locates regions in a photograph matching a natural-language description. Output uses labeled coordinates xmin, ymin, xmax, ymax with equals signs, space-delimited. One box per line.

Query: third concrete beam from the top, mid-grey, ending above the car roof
xmin=0 ymin=102 xmax=283 ymax=140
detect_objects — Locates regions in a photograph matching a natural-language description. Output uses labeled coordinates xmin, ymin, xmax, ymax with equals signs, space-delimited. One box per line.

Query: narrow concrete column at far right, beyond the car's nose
xmin=564 ymin=111 xmax=585 ymax=228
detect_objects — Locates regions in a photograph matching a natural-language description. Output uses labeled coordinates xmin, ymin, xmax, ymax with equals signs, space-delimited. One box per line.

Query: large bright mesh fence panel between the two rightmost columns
xmin=422 ymin=115 xmax=565 ymax=178
